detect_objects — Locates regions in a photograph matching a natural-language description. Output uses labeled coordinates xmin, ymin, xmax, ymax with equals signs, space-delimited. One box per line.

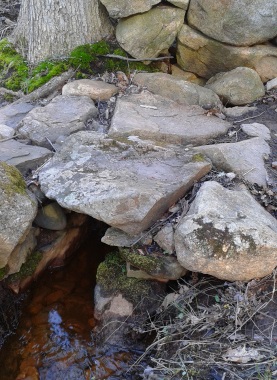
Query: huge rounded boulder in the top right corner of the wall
xmin=185 ymin=0 xmax=277 ymax=46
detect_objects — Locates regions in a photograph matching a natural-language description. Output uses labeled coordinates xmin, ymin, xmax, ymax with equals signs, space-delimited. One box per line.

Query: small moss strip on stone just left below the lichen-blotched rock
xmin=120 ymin=249 xmax=161 ymax=273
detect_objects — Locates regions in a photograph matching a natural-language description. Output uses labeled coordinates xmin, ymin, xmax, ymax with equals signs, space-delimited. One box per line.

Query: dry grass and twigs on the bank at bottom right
xmin=132 ymin=271 xmax=277 ymax=380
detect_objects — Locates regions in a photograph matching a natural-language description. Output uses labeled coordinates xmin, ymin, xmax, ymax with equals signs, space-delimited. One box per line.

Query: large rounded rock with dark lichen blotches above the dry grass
xmin=175 ymin=181 xmax=277 ymax=281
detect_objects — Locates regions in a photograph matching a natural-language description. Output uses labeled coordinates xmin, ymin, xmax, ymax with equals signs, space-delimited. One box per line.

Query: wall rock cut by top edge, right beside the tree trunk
xmin=101 ymin=0 xmax=160 ymax=18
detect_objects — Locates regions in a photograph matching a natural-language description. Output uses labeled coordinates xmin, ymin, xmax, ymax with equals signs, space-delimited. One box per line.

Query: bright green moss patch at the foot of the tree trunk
xmin=0 ymin=39 xmax=157 ymax=93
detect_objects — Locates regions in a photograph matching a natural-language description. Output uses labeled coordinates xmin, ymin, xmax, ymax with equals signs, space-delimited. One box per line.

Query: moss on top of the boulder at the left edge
xmin=0 ymin=162 xmax=26 ymax=195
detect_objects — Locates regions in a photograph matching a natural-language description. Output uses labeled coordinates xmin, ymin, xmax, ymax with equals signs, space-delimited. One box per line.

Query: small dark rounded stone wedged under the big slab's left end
xmin=34 ymin=202 xmax=67 ymax=231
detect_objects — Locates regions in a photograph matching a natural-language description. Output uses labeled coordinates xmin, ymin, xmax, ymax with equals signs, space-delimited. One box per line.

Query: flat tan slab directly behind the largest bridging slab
xmin=108 ymin=91 xmax=232 ymax=145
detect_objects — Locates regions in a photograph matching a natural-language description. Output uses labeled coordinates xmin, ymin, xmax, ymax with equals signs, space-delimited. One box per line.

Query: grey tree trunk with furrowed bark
xmin=11 ymin=0 xmax=113 ymax=63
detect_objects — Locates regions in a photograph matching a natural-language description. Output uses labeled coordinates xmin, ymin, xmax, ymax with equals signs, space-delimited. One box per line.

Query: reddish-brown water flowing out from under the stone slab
xmin=0 ymin=230 xmax=137 ymax=380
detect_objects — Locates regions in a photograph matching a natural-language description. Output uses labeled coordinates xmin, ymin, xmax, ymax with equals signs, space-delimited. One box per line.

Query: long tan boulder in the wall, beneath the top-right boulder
xmin=177 ymin=25 xmax=277 ymax=82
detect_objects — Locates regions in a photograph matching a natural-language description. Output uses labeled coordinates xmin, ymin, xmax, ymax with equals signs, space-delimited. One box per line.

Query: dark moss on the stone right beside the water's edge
xmin=96 ymin=252 xmax=150 ymax=304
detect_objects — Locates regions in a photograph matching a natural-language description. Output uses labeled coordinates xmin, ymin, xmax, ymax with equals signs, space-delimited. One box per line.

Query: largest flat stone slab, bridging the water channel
xmin=39 ymin=131 xmax=211 ymax=235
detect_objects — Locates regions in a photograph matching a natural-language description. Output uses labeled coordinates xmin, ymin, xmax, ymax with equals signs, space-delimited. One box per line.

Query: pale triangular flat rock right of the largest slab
xmin=193 ymin=137 xmax=270 ymax=186
